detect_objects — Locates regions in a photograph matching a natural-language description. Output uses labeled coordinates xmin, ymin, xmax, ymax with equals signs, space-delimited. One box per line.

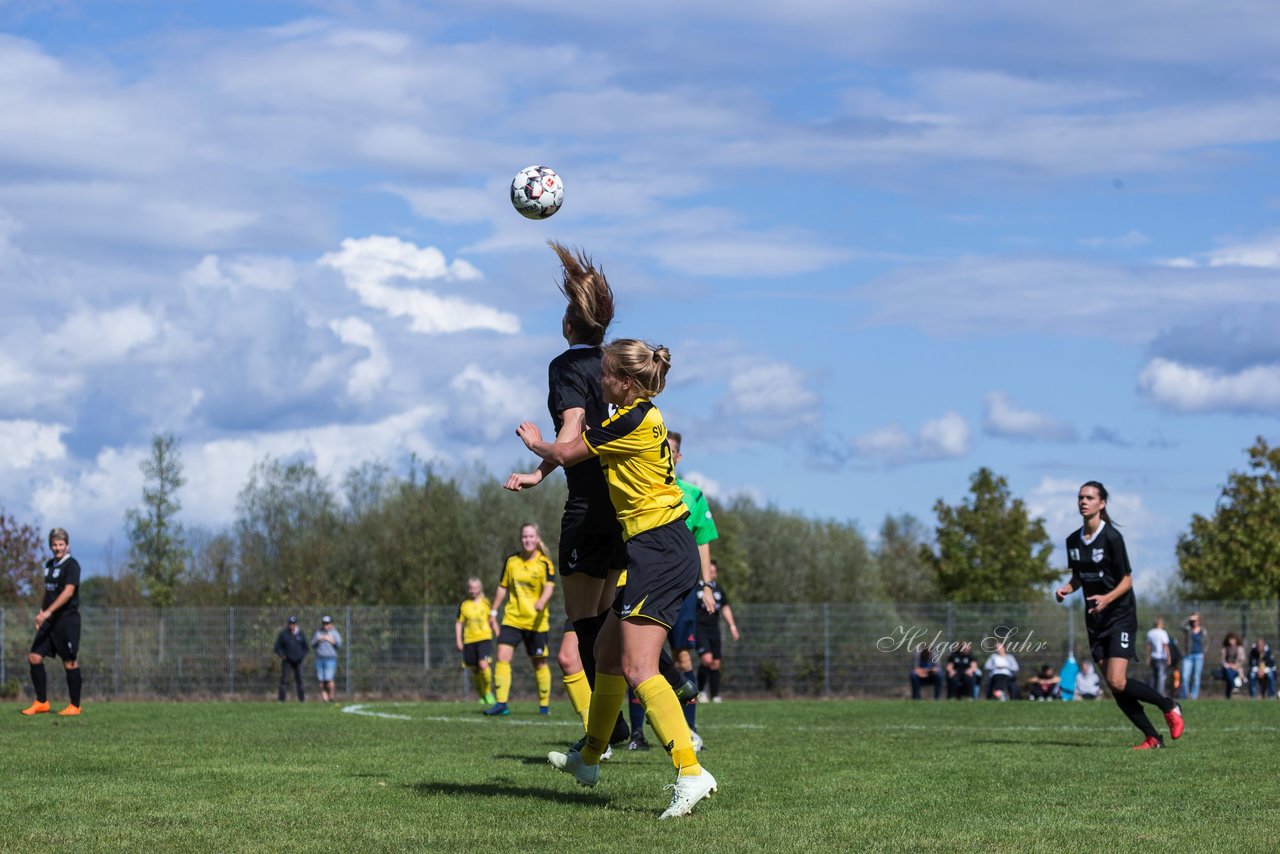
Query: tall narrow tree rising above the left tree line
xmin=125 ymin=433 xmax=187 ymax=608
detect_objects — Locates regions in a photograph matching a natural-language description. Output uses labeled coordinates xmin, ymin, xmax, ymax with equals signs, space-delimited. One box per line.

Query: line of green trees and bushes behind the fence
xmin=0 ymin=434 xmax=1280 ymax=607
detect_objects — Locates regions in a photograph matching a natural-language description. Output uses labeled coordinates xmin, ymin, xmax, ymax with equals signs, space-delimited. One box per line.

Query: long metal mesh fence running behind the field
xmin=0 ymin=602 xmax=1280 ymax=702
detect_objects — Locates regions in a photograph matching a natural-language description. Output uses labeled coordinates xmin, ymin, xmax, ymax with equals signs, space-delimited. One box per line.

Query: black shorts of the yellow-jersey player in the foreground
xmin=613 ymin=519 xmax=701 ymax=629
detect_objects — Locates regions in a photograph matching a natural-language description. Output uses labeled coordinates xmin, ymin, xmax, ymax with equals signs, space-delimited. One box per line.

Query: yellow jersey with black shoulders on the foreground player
xmin=582 ymin=398 xmax=689 ymax=539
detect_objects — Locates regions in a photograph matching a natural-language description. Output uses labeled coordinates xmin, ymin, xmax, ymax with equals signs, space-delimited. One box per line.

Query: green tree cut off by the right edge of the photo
xmin=1178 ymin=437 xmax=1280 ymax=599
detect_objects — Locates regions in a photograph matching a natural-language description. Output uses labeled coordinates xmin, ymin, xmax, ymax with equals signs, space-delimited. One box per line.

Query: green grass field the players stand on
xmin=0 ymin=700 xmax=1280 ymax=853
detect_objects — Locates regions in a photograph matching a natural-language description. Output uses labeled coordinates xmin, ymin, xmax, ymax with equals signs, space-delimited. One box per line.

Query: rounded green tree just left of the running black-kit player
xmin=922 ymin=467 xmax=1059 ymax=602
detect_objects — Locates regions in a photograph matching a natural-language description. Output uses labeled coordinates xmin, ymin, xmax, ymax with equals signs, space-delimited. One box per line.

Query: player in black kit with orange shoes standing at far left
xmin=22 ymin=528 xmax=81 ymax=717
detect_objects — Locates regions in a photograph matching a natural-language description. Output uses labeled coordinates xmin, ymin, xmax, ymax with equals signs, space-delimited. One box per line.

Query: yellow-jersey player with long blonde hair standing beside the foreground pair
xmin=484 ymin=524 xmax=556 ymax=716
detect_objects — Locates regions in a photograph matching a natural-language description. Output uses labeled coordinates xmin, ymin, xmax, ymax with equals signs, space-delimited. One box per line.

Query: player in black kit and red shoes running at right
xmin=1055 ymin=480 xmax=1183 ymax=750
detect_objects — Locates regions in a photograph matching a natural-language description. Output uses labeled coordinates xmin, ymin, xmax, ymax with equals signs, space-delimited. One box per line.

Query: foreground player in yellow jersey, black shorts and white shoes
xmin=516 ymin=339 xmax=717 ymax=818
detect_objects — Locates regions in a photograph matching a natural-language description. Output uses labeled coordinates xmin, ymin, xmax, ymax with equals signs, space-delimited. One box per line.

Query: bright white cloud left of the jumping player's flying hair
xmin=320 ymin=236 xmax=520 ymax=334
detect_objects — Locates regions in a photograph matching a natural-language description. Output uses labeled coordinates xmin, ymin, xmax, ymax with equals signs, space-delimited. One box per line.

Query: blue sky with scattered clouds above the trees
xmin=0 ymin=0 xmax=1280 ymax=589
